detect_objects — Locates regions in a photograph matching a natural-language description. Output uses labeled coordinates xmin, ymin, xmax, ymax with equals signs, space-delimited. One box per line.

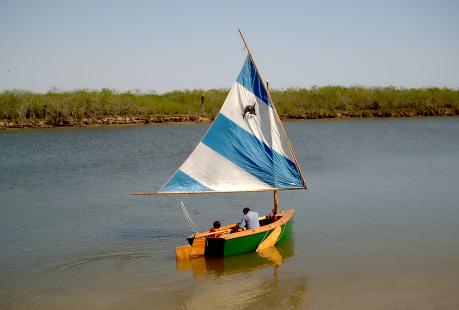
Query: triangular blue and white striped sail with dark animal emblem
xmin=160 ymin=56 xmax=306 ymax=193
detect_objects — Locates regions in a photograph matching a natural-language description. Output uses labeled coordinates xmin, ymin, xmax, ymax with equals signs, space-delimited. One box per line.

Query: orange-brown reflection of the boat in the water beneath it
xmin=176 ymin=225 xmax=307 ymax=309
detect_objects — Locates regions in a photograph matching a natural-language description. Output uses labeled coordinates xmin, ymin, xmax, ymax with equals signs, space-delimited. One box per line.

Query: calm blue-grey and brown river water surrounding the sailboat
xmin=0 ymin=118 xmax=459 ymax=309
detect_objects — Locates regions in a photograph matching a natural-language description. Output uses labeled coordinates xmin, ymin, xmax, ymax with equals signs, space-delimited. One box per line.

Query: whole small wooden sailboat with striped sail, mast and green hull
xmin=133 ymin=29 xmax=307 ymax=259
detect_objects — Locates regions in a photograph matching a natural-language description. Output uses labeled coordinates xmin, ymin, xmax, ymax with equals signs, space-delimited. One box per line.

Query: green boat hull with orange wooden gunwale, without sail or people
xmin=189 ymin=209 xmax=294 ymax=257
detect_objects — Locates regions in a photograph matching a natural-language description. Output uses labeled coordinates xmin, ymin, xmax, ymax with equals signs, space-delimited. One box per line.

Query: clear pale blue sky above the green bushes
xmin=0 ymin=0 xmax=459 ymax=93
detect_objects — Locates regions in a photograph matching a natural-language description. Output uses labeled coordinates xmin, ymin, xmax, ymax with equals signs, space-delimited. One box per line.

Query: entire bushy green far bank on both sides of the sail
xmin=0 ymin=86 xmax=459 ymax=128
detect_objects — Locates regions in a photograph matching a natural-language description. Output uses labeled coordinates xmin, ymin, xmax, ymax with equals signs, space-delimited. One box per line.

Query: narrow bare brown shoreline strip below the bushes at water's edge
xmin=0 ymin=110 xmax=458 ymax=131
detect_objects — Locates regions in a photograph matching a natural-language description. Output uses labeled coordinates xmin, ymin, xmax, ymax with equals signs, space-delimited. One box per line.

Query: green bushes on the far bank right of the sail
xmin=271 ymin=86 xmax=459 ymax=118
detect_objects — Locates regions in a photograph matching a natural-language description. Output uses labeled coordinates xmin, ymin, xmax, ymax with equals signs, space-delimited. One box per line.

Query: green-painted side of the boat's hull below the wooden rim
xmin=204 ymin=219 xmax=292 ymax=257
